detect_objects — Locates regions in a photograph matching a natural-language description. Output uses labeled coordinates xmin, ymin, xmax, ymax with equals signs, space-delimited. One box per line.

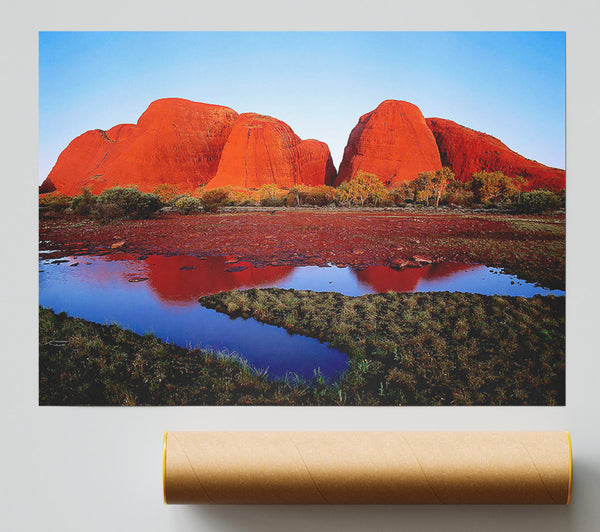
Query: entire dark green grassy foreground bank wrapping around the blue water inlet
xmin=39 ymin=288 xmax=565 ymax=405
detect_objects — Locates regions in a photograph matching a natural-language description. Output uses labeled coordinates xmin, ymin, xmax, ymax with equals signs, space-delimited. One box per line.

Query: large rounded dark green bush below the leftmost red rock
xmin=92 ymin=187 xmax=162 ymax=219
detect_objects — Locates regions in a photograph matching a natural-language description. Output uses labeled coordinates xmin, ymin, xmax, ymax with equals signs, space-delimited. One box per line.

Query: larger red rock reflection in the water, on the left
xmin=144 ymin=255 xmax=294 ymax=303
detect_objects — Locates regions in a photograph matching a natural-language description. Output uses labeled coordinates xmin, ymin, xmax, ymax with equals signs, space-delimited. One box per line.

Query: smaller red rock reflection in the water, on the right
xmin=354 ymin=262 xmax=472 ymax=292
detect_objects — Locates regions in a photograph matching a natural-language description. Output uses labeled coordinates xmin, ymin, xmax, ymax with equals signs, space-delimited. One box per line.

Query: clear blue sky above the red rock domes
xmin=39 ymin=32 xmax=565 ymax=182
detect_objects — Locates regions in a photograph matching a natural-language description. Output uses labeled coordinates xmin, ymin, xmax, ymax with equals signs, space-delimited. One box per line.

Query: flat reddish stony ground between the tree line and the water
xmin=40 ymin=209 xmax=565 ymax=288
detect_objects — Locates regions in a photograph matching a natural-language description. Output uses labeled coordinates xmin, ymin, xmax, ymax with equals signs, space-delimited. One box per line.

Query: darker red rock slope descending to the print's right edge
xmin=427 ymin=118 xmax=565 ymax=192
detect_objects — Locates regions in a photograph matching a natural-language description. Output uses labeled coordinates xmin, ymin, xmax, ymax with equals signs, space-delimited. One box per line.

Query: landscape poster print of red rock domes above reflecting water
xmin=39 ymin=32 xmax=565 ymax=406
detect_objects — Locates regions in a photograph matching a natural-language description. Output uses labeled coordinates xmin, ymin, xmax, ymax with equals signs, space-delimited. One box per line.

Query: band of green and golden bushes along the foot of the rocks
xmin=39 ymin=167 xmax=565 ymax=222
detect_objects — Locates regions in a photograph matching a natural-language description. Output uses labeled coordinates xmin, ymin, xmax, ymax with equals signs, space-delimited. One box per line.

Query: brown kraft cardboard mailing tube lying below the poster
xmin=163 ymin=432 xmax=572 ymax=504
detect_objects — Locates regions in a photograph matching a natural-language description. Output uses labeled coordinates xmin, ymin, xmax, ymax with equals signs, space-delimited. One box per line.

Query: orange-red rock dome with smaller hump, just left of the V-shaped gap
xmin=207 ymin=113 xmax=335 ymax=189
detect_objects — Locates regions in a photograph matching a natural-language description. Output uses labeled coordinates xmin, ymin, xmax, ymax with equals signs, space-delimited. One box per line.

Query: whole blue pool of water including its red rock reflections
xmin=39 ymin=253 xmax=564 ymax=379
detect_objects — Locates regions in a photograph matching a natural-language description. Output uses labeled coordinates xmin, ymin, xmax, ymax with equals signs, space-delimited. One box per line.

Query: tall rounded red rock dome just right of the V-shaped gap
xmin=335 ymin=100 xmax=442 ymax=186
